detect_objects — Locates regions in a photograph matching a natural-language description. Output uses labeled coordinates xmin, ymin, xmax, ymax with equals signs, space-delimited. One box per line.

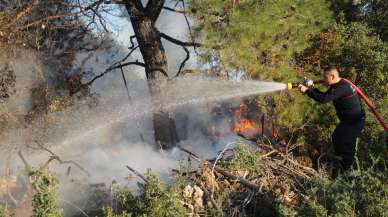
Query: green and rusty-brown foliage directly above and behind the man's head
xmin=297 ymin=23 xmax=388 ymax=99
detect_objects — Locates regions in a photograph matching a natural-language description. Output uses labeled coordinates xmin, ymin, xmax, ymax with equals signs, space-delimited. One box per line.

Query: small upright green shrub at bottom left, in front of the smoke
xmin=27 ymin=168 xmax=62 ymax=217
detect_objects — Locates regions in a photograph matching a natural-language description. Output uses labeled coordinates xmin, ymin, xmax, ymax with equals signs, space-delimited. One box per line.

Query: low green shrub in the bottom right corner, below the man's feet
xmin=298 ymin=165 xmax=388 ymax=217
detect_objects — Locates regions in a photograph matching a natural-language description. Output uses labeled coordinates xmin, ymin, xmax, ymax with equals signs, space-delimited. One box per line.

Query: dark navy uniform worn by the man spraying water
xmin=306 ymin=79 xmax=365 ymax=170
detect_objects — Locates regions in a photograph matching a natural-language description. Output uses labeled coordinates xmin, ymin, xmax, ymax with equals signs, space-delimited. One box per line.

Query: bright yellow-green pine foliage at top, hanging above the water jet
xmin=191 ymin=0 xmax=331 ymax=80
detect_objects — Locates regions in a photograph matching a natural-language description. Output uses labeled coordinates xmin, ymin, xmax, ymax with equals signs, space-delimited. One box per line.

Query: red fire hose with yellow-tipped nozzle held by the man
xmin=287 ymin=78 xmax=388 ymax=132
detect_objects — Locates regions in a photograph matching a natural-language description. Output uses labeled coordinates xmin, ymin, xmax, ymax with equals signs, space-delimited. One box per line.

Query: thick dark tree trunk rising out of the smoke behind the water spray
xmin=126 ymin=0 xmax=178 ymax=149
